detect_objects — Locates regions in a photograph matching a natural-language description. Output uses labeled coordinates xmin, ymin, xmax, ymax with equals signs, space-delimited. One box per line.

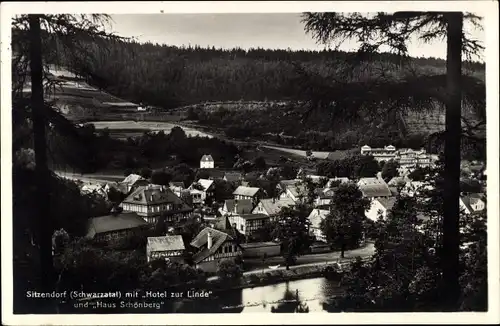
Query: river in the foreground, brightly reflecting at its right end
xmin=60 ymin=277 xmax=341 ymax=314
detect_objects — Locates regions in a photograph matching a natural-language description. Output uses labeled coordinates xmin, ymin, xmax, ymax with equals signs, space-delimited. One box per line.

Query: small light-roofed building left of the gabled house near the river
xmin=146 ymin=235 xmax=186 ymax=263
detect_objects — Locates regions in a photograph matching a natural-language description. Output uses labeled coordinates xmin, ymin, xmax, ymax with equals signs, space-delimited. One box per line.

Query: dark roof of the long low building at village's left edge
xmin=87 ymin=212 xmax=147 ymax=238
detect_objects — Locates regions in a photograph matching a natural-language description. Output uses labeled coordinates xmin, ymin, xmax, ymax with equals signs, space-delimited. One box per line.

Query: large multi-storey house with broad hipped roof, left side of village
xmin=120 ymin=185 xmax=193 ymax=223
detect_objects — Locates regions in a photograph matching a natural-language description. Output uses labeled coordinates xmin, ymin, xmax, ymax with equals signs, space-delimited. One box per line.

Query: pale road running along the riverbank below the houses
xmin=207 ymin=243 xmax=375 ymax=281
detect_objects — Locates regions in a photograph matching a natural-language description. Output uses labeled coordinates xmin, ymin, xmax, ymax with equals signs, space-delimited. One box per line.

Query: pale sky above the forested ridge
xmin=111 ymin=13 xmax=484 ymax=58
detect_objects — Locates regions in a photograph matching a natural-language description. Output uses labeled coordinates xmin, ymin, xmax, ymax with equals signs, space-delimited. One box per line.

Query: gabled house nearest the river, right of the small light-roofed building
xmin=191 ymin=227 xmax=242 ymax=272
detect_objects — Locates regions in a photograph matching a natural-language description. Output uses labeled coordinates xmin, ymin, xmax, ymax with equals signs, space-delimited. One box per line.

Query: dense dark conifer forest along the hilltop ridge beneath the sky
xmin=47 ymin=40 xmax=484 ymax=109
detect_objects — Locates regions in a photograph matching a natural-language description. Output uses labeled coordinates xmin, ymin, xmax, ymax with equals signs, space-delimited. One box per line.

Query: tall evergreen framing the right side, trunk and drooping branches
xmin=303 ymin=12 xmax=485 ymax=311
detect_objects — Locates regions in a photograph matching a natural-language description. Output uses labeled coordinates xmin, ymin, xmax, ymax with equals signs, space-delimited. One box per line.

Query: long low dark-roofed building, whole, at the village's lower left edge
xmin=86 ymin=210 xmax=148 ymax=241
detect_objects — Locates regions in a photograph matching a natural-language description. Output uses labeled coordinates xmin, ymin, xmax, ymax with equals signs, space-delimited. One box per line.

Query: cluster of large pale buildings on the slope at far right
xmin=361 ymin=145 xmax=436 ymax=169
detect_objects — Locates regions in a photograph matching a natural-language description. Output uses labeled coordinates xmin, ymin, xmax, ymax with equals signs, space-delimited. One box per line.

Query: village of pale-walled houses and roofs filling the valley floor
xmin=70 ymin=141 xmax=486 ymax=275
